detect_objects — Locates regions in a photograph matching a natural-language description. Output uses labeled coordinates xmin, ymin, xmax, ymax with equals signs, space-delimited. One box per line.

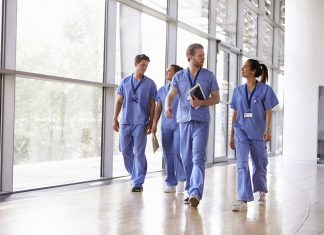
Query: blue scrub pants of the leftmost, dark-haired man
xmin=119 ymin=124 xmax=147 ymax=187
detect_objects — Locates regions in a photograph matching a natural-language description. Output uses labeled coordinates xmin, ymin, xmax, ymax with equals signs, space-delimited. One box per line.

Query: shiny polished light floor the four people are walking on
xmin=0 ymin=156 xmax=324 ymax=235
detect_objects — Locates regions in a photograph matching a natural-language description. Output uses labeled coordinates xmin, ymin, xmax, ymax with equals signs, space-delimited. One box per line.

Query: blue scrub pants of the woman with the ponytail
xmin=234 ymin=127 xmax=268 ymax=202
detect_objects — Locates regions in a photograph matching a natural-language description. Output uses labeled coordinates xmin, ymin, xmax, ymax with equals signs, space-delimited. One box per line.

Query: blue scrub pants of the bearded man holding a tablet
xmin=179 ymin=121 xmax=209 ymax=199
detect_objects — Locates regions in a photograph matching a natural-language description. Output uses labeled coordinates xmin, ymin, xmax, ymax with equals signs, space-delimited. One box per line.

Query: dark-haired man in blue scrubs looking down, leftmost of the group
xmin=112 ymin=54 xmax=156 ymax=192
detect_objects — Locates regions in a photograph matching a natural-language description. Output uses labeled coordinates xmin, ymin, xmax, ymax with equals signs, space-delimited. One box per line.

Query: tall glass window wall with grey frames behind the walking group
xmin=0 ymin=0 xmax=285 ymax=191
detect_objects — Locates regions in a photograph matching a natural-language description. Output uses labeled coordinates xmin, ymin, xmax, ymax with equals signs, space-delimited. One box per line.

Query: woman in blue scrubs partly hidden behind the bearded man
xmin=152 ymin=64 xmax=186 ymax=193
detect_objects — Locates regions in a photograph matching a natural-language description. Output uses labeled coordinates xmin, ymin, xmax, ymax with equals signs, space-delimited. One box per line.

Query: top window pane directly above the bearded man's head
xmin=178 ymin=0 xmax=208 ymax=33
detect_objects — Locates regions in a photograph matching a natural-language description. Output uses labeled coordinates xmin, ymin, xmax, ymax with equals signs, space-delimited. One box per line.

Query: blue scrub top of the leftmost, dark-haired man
xmin=117 ymin=75 xmax=156 ymax=124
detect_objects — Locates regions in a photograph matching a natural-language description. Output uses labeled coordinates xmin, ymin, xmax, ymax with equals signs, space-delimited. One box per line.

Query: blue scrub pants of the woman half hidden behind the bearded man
xmin=162 ymin=127 xmax=186 ymax=186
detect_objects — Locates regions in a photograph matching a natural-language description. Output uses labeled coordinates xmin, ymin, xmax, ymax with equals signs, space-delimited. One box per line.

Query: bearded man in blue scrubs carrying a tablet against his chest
xmin=165 ymin=43 xmax=219 ymax=207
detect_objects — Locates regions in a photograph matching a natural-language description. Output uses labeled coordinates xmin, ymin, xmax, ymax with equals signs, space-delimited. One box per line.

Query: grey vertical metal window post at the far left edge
xmin=0 ymin=0 xmax=17 ymax=192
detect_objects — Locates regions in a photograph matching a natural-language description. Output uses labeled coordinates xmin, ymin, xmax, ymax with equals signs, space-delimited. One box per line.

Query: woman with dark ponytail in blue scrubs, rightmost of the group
xmin=230 ymin=59 xmax=279 ymax=211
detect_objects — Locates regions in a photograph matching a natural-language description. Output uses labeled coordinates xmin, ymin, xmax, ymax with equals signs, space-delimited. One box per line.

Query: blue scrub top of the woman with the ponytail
xmin=231 ymin=82 xmax=279 ymax=140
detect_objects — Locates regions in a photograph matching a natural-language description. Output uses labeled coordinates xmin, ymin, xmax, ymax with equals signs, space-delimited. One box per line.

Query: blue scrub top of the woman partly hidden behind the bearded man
xmin=155 ymin=84 xmax=179 ymax=130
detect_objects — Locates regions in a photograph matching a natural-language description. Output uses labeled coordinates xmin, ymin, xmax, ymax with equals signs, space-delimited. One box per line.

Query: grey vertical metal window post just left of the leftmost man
xmin=101 ymin=0 xmax=117 ymax=178
